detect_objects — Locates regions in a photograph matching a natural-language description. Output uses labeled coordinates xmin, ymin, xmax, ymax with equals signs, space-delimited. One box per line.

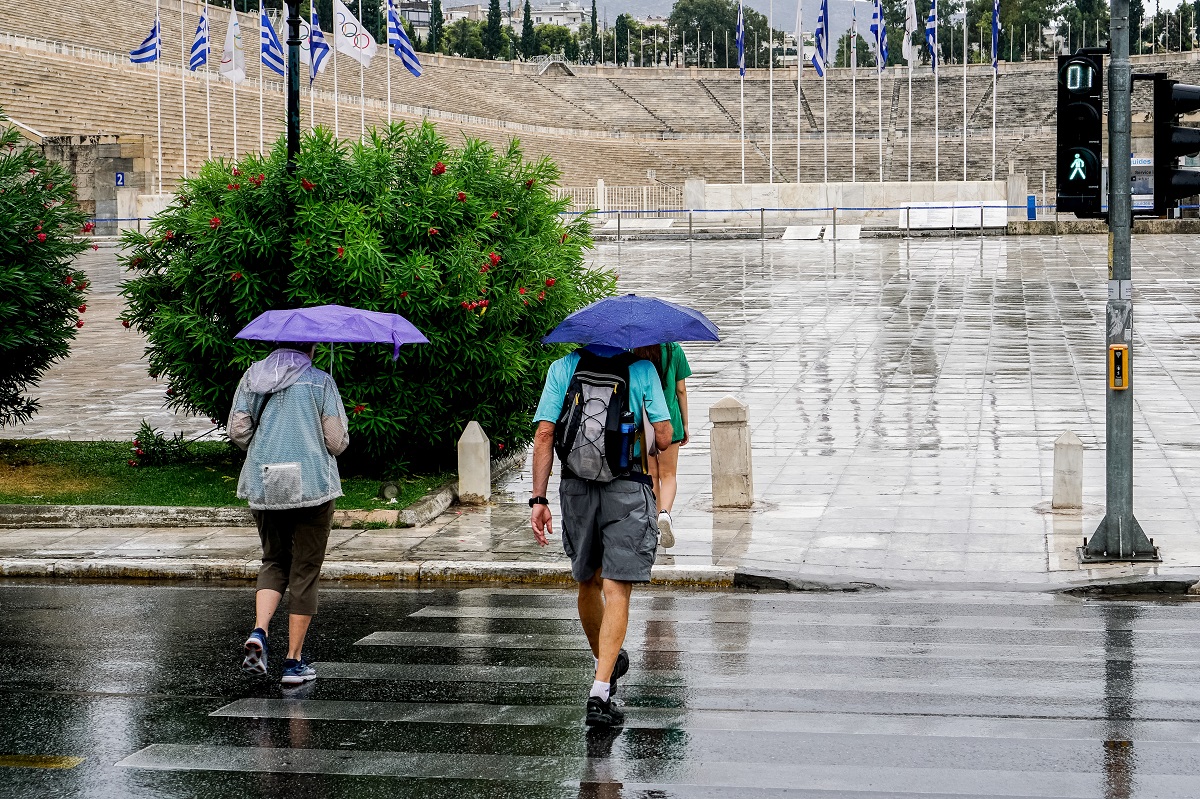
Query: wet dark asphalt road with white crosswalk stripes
xmin=0 ymin=581 xmax=1200 ymax=799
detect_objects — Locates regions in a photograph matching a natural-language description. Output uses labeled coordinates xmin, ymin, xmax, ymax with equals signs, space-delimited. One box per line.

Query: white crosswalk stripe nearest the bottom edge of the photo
xmin=118 ymin=744 xmax=1194 ymax=799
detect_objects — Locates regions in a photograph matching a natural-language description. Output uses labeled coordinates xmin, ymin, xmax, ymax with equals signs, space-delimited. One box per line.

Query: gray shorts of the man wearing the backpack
xmin=558 ymin=477 xmax=659 ymax=583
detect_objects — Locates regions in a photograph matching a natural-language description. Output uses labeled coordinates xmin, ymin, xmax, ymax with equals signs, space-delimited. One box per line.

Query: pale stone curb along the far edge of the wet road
xmin=0 ymin=558 xmax=734 ymax=588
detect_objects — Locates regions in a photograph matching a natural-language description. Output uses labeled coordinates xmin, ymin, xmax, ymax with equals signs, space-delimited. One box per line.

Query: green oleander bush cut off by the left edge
xmin=0 ymin=110 xmax=91 ymax=427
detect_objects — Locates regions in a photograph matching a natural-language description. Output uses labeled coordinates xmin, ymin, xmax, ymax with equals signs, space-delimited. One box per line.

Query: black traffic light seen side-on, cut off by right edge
xmin=1154 ymin=74 xmax=1200 ymax=216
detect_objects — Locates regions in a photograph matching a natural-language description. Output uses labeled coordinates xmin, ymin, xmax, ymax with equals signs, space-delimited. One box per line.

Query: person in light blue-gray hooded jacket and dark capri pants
xmin=228 ymin=343 xmax=350 ymax=685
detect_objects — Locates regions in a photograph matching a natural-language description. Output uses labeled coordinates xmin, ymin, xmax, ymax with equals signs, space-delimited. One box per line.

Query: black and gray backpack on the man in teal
xmin=554 ymin=350 xmax=638 ymax=482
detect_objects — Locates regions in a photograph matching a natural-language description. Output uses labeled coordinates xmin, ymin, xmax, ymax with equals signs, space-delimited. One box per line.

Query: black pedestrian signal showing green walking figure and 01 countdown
xmin=1056 ymin=53 xmax=1104 ymax=217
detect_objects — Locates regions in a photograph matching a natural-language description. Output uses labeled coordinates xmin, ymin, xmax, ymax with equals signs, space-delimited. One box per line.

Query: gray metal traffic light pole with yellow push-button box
xmin=1079 ymin=0 xmax=1162 ymax=563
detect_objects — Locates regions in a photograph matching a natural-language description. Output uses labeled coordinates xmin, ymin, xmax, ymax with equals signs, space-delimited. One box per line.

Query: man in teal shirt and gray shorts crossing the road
xmin=529 ymin=346 xmax=671 ymax=726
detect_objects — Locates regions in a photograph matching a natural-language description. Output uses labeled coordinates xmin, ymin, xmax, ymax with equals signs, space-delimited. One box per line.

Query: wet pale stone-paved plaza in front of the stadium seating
xmin=6 ymin=236 xmax=1200 ymax=588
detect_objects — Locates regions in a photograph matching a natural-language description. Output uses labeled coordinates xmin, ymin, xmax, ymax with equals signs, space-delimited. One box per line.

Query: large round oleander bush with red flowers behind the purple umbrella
xmin=122 ymin=124 xmax=616 ymax=474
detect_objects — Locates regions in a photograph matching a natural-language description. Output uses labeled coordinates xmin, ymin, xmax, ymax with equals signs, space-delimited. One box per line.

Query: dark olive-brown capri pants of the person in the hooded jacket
xmin=251 ymin=499 xmax=334 ymax=615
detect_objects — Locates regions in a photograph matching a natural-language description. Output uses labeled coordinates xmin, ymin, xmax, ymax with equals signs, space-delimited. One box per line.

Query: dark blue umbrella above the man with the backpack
xmin=541 ymin=294 xmax=720 ymax=349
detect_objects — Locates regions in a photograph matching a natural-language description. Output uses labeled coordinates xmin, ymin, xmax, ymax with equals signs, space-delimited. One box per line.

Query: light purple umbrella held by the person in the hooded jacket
xmin=235 ymin=305 xmax=430 ymax=360
